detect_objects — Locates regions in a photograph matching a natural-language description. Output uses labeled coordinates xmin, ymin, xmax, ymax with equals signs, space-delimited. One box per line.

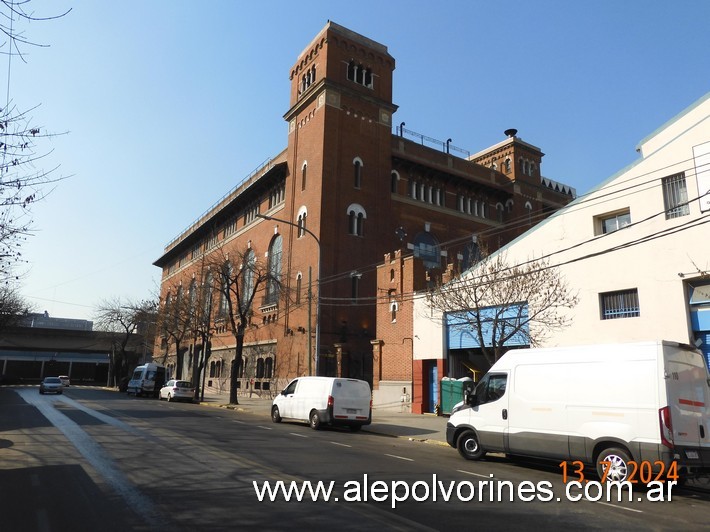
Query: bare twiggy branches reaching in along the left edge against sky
xmin=0 ymin=0 xmax=69 ymax=280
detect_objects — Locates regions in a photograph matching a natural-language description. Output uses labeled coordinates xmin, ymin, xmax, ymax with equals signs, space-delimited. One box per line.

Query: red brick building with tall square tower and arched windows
xmin=155 ymin=22 xmax=574 ymax=392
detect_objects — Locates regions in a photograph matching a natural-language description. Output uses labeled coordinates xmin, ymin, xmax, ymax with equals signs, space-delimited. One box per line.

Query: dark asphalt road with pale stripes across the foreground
xmin=0 ymin=387 xmax=710 ymax=532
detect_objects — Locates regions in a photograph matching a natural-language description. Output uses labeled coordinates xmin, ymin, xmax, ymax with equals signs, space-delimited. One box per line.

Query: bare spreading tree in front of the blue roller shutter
xmin=427 ymin=253 xmax=578 ymax=365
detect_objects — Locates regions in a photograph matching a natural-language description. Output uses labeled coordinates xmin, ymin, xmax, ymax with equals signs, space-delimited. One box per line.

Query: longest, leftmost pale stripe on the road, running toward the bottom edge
xmin=15 ymin=389 xmax=164 ymax=529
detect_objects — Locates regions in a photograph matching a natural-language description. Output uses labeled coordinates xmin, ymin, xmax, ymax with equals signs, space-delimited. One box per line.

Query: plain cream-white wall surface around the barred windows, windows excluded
xmin=414 ymin=94 xmax=710 ymax=352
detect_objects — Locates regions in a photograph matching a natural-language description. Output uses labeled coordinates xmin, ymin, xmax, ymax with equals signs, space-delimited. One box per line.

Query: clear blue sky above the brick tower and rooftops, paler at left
xmin=5 ymin=0 xmax=710 ymax=319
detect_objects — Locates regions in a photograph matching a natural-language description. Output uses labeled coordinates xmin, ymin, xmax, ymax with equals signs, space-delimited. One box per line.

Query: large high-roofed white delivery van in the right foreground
xmin=446 ymin=342 xmax=710 ymax=480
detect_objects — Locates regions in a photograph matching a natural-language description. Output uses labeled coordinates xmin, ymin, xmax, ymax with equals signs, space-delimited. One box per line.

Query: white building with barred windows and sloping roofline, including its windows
xmin=414 ymin=93 xmax=710 ymax=372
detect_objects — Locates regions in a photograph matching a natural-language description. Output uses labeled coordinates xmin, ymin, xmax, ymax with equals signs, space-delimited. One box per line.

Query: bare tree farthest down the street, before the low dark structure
xmin=94 ymin=297 xmax=156 ymax=382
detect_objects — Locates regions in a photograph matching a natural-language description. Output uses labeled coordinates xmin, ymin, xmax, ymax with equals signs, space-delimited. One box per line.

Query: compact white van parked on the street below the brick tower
xmin=271 ymin=377 xmax=372 ymax=431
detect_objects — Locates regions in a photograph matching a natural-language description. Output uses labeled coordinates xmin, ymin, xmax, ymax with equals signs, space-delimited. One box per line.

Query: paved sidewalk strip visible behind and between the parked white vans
xmin=202 ymin=388 xmax=448 ymax=445
